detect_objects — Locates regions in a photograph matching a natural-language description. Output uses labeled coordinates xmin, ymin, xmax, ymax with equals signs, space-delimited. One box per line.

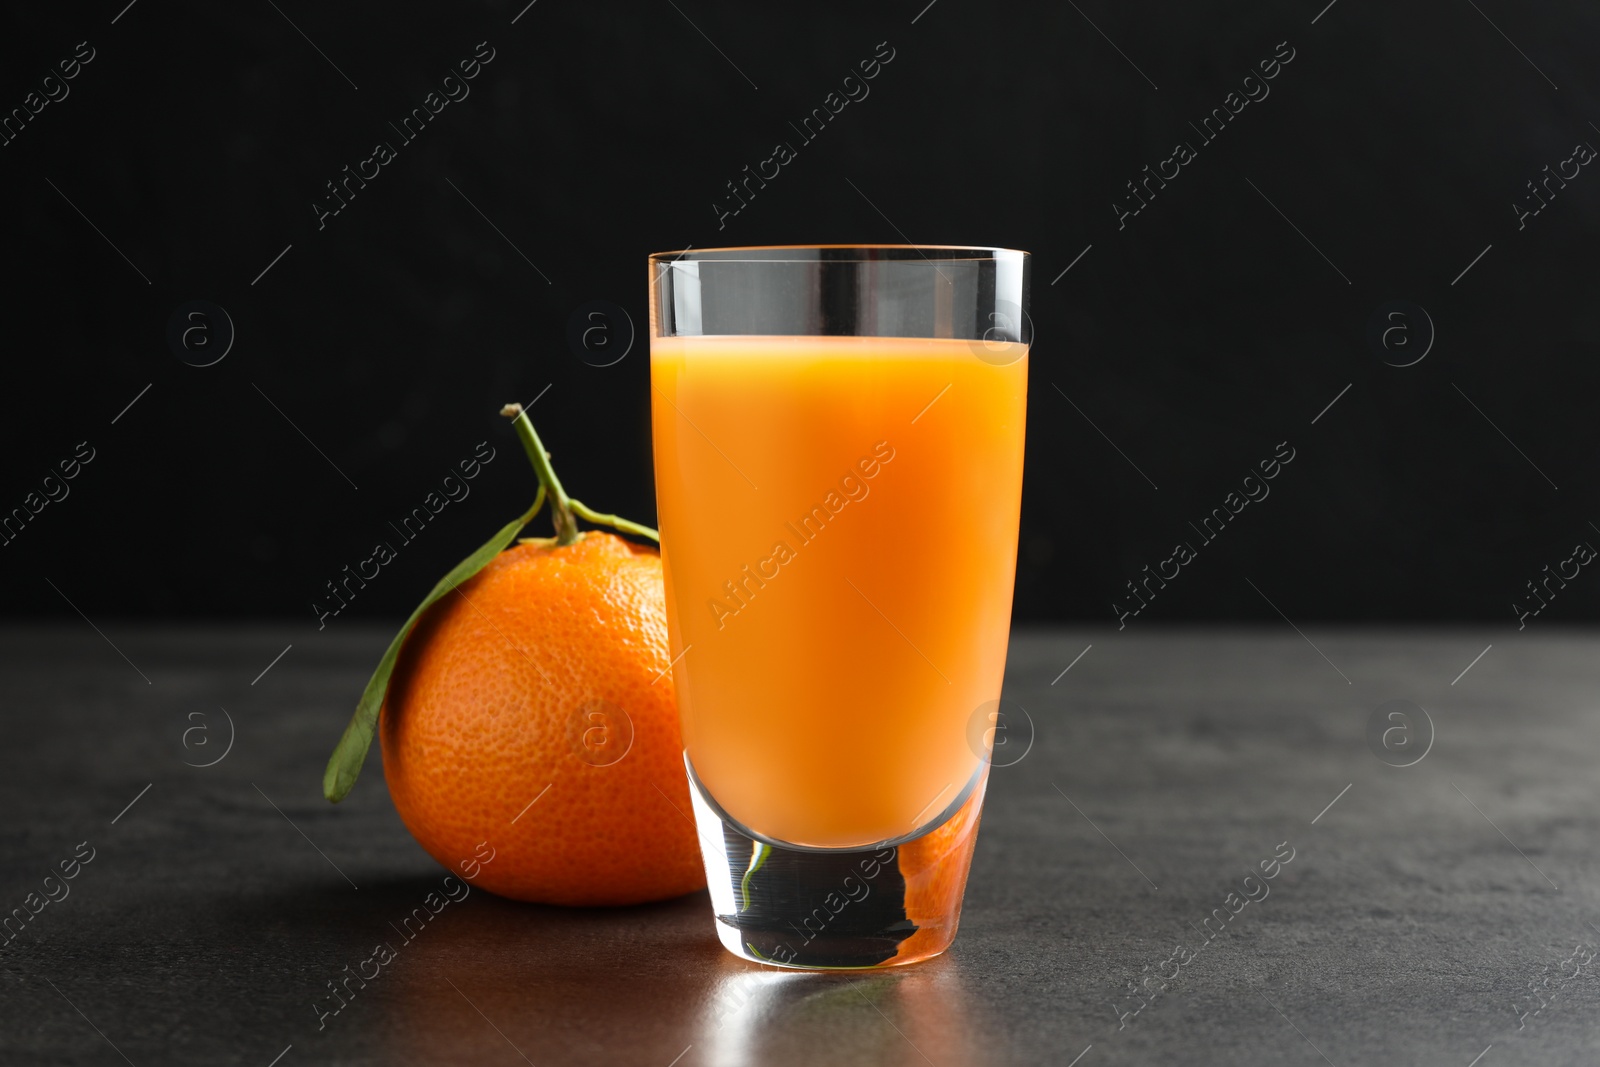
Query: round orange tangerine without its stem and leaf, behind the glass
xmin=378 ymin=531 xmax=706 ymax=905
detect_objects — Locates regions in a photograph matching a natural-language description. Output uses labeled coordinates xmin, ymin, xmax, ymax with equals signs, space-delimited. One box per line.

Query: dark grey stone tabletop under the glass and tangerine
xmin=0 ymin=619 xmax=1600 ymax=1067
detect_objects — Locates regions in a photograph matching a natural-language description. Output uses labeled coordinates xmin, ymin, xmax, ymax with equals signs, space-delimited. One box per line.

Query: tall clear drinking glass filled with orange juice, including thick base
xmin=650 ymin=245 xmax=1032 ymax=968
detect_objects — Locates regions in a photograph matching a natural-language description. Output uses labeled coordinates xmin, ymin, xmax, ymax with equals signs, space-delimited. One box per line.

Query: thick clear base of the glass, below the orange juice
xmin=685 ymin=760 xmax=989 ymax=971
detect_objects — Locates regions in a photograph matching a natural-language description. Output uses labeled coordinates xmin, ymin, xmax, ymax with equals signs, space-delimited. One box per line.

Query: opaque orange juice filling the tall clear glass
xmin=651 ymin=336 xmax=1027 ymax=848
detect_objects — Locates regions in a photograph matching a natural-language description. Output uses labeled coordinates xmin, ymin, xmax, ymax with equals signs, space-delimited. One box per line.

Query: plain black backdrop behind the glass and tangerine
xmin=0 ymin=0 xmax=1600 ymax=625
